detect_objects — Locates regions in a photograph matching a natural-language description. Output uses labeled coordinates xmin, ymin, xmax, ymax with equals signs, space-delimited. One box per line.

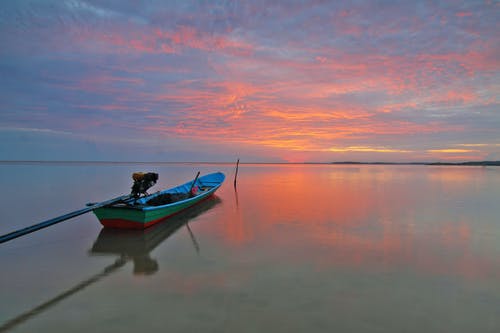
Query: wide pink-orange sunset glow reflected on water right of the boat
xmin=213 ymin=166 xmax=500 ymax=278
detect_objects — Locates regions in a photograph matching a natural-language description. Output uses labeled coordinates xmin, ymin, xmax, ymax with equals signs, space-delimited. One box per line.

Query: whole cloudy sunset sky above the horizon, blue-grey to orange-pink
xmin=0 ymin=0 xmax=500 ymax=162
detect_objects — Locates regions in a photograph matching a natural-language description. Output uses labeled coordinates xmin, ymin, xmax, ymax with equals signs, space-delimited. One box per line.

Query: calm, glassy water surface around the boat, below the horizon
xmin=0 ymin=164 xmax=500 ymax=333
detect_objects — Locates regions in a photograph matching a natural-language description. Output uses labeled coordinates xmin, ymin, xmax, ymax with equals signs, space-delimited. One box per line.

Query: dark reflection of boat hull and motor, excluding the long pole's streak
xmin=89 ymin=196 xmax=221 ymax=275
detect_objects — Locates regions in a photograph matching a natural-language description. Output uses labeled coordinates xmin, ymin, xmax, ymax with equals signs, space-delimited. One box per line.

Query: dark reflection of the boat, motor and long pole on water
xmin=0 ymin=196 xmax=221 ymax=332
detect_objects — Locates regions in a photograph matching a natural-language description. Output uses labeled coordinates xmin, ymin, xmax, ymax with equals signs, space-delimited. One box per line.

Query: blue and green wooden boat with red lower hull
xmin=93 ymin=172 xmax=225 ymax=229
